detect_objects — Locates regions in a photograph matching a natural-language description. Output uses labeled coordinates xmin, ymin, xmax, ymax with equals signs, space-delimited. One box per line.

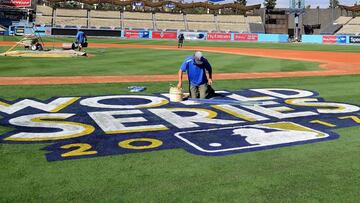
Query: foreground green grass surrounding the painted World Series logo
xmin=0 ymin=75 xmax=360 ymax=202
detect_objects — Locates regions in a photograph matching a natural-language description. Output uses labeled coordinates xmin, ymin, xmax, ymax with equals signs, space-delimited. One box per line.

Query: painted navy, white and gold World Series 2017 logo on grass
xmin=0 ymin=88 xmax=360 ymax=161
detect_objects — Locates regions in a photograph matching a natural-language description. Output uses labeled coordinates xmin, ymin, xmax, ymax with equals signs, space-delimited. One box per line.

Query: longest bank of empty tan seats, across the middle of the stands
xmin=36 ymin=5 xmax=264 ymax=33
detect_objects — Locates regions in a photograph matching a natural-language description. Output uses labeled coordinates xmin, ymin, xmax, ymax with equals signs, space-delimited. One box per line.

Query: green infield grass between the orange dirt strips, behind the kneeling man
xmin=0 ymin=47 xmax=319 ymax=76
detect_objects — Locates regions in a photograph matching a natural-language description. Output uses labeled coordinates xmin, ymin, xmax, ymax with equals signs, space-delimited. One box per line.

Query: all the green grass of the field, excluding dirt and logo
xmin=0 ymin=39 xmax=360 ymax=202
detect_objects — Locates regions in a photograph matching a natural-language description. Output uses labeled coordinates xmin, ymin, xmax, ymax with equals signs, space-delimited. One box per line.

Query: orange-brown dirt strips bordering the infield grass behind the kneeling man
xmin=0 ymin=41 xmax=360 ymax=85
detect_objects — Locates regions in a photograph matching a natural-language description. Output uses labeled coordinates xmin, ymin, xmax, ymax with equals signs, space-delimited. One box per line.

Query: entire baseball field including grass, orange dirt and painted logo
xmin=0 ymin=38 xmax=360 ymax=202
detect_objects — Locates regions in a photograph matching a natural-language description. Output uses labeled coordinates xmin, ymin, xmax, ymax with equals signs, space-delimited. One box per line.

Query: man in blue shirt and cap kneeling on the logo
xmin=177 ymin=51 xmax=214 ymax=99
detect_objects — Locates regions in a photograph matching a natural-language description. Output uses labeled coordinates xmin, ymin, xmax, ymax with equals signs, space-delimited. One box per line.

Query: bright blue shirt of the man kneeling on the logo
xmin=180 ymin=56 xmax=211 ymax=86
